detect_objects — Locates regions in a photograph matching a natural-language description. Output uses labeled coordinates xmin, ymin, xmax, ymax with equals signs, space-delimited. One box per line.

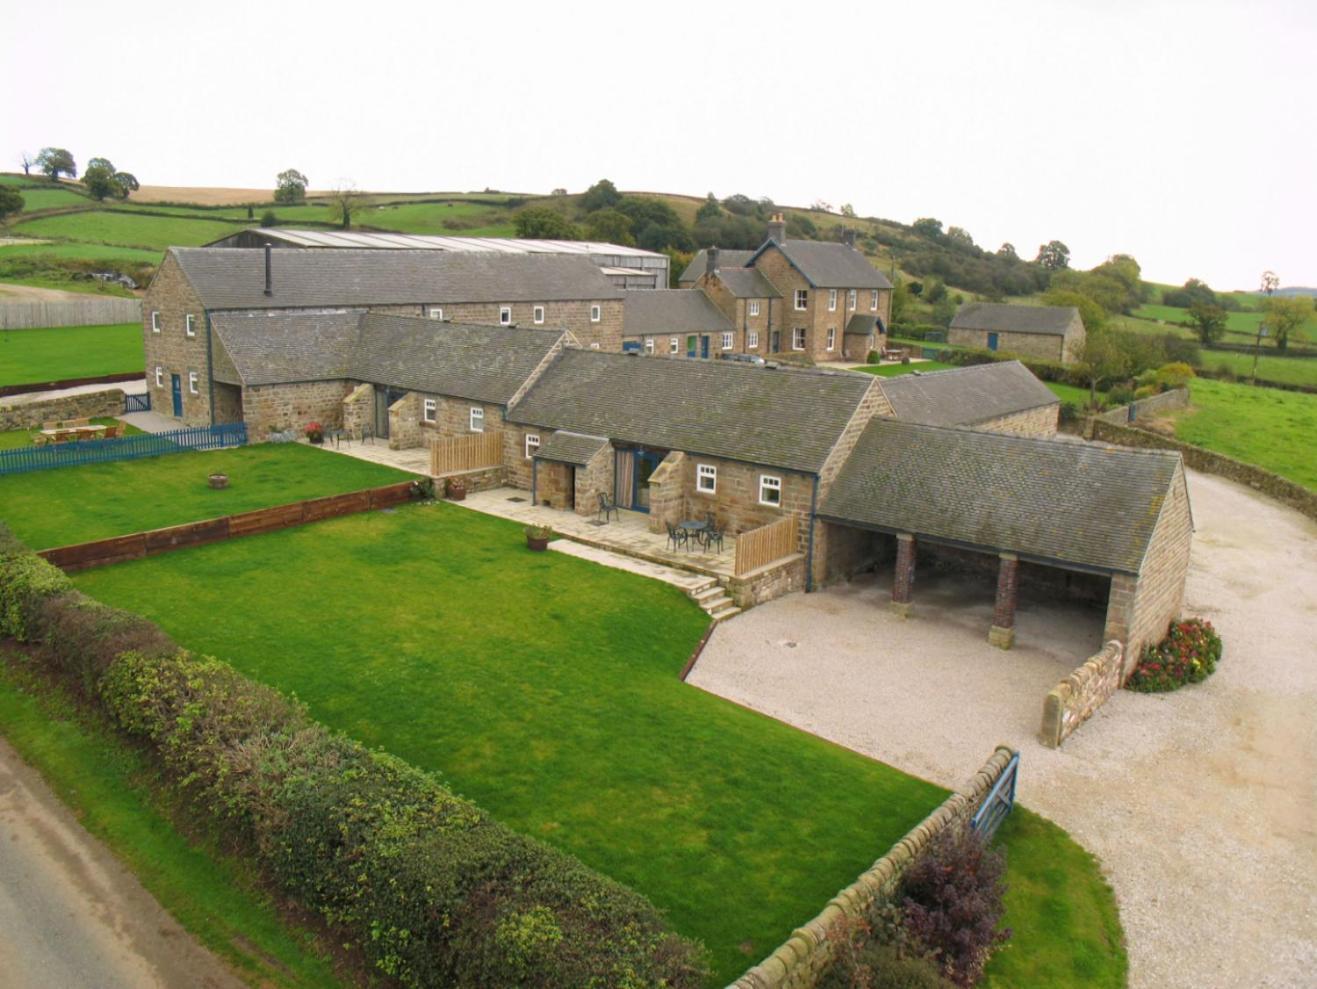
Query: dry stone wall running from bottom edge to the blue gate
xmin=730 ymin=745 xmax=1017 ymax=989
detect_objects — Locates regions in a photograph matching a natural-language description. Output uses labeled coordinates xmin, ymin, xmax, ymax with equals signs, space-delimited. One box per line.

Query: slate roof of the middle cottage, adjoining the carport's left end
xmin=508 ymin=350 xmax=872 ymax=473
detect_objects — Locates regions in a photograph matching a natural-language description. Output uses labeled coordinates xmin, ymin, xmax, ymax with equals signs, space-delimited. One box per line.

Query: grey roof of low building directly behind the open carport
xmin=880 ymin=361 xmax=1060 ymax=425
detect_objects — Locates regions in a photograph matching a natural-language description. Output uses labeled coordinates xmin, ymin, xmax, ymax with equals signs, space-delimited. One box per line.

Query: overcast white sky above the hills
xmin=0 ymin=0 xmax=1317 ymax=290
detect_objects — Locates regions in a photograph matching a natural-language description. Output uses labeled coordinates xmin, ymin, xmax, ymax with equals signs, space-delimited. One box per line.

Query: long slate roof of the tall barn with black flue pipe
xmin=169 ymin=248 xmax=624 ymax=309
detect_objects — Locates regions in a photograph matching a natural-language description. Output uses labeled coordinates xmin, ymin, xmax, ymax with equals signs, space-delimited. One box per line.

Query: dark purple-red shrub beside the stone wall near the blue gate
xmin=901 ymin=827 xmax=1010 ymax=986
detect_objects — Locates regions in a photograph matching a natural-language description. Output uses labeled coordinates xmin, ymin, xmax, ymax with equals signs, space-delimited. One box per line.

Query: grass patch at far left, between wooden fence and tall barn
xmin=0 ymin=323 xmax=146 ymax=385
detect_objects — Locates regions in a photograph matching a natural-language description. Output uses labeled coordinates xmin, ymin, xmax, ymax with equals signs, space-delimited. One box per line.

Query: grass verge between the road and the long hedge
xmin=0 ymin=647 xmax=340 ymax=989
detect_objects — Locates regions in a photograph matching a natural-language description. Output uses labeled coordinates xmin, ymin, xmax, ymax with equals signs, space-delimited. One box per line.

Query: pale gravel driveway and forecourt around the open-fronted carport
xmin=689 ymin=471 xmax=1317 ymax=989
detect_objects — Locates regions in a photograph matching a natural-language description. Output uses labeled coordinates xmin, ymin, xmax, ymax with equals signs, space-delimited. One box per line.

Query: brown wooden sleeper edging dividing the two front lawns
xmin=37 ymin=481 xmax=417 ymax=573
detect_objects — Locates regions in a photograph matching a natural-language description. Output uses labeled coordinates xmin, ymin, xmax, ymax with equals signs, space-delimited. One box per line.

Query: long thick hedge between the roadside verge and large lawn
xmin=0 ymin=525 xmax=707 ymax=989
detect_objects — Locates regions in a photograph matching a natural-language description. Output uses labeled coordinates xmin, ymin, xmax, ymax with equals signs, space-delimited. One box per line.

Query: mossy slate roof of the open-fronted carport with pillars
xmin=819 ymin=419 xmax=1183 ymax=574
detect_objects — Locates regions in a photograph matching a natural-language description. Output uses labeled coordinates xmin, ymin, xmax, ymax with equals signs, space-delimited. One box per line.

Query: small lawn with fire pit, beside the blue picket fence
xmin=0 ymin=444 xmax=412 ymax=549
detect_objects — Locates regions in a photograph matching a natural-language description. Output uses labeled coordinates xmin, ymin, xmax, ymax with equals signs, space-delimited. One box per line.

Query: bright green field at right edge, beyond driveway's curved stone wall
xmin=1175 ymin=378 xmax=1317 ymax=490
